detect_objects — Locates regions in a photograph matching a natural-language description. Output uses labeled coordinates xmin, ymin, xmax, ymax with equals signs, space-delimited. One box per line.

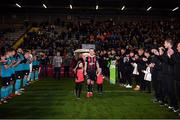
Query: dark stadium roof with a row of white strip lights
xmin=0 ymin=0 xmax=180 ymax=14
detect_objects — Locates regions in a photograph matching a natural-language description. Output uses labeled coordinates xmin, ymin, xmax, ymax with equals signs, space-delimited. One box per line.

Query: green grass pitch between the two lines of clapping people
xmin=0 ymin=78 xmax=180 ymax=119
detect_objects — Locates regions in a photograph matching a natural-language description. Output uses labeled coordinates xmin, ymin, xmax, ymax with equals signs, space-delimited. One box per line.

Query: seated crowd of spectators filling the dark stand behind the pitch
xmin=23 ymin=20 xmax=180 ymax=53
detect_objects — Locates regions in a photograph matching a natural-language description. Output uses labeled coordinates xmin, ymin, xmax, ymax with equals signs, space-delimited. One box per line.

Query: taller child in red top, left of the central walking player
xmin=74 ymin=62 xmax=84 ymax=99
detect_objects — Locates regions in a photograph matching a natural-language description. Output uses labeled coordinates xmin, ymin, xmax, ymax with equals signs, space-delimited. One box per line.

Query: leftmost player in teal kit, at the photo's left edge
xmin=1 ymin=56 xmax=12 ymax=103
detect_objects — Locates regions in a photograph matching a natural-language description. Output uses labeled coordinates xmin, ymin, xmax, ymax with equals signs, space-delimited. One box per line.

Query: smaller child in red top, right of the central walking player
xmin=96 ymin=68 xmax=104 ymax=94
